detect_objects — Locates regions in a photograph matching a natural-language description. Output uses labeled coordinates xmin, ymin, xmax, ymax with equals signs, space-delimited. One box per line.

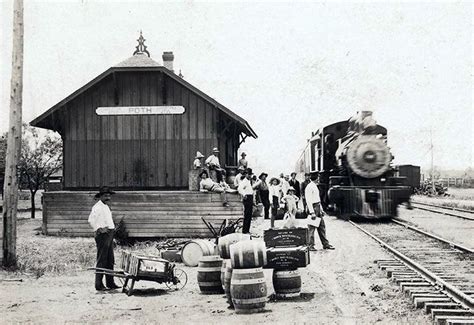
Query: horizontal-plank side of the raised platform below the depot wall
xmin=43 ymin=191 xmax=243 ymax=238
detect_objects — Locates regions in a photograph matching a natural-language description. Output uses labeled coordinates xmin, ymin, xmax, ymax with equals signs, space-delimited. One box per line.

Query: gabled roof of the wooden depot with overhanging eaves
xmin=30 ymin=53 xmax=257 ymax=138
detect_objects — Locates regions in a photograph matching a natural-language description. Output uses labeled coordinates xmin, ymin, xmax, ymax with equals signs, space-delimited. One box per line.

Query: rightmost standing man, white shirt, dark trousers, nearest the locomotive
xmin=305 ymin=172 xmax=334 ymax=251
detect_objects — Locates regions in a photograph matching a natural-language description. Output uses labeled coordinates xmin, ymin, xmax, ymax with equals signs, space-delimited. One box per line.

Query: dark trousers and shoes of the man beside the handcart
xmin=95 ymin=230 xmax=114 ymax=288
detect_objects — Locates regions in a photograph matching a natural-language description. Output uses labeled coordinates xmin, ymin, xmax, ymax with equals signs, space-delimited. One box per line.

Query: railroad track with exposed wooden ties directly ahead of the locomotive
xmin=350 ymin=220 xmax=474 ymax=324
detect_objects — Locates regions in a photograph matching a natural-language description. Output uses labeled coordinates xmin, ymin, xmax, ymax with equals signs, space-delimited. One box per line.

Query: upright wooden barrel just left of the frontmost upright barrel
xmin=197 ymin=255 xmax=224 ymax=295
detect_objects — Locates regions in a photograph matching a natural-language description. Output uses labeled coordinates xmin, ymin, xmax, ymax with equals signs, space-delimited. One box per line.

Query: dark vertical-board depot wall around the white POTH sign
xmin=54 ymin=71 xmax=240 ymax=189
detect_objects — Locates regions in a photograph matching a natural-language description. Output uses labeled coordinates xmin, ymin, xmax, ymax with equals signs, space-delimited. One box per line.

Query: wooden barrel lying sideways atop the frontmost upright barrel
xmin=230 ymin=240 xmax=267 ymax=269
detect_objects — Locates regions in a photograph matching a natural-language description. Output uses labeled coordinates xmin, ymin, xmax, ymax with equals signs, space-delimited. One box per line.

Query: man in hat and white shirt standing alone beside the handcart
xmin=88 ymin=186 xmax=119 ymax=291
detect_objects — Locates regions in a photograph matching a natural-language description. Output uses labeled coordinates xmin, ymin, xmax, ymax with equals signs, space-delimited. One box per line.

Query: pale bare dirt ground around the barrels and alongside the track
xmin=0 ymin=213 xmax=430 ymax=324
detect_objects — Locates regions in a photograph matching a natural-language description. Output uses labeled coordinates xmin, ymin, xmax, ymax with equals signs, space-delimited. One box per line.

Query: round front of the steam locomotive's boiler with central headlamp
xmin=347 ymin=136 xmax=392 ymax=178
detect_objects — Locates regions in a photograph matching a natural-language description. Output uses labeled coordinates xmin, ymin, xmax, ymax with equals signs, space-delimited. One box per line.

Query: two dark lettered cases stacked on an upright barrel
xmin=264 ymin=228 xmax=309 ymax=299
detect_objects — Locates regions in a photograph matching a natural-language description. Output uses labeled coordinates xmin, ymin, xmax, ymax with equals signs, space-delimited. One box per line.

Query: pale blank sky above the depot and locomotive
xmin=0 ymin=0 xmax=474 ymax=174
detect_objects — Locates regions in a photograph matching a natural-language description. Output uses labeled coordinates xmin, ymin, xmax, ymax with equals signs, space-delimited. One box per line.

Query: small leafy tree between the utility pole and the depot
xmin=18 ymin=123 xmax=62 ymax=218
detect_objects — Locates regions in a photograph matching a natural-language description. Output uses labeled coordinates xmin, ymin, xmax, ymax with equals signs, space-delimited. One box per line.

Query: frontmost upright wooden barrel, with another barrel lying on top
xmin=230 ymin=267 xmax=267 ymax=314
